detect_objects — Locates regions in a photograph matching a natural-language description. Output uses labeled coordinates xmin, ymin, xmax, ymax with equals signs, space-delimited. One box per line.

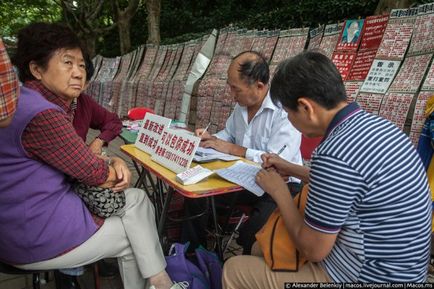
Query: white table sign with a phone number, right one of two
xmin=152 ymin=128 xmax=200 ymax=174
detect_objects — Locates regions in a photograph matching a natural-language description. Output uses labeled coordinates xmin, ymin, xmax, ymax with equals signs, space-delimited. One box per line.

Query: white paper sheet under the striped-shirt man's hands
xmin=214 ymin=161 xmax=264 ymax=197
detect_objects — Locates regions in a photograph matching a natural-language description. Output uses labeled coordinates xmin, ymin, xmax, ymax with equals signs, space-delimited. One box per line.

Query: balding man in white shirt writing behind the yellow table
xmin=182 ymin=51 xmax=302 ymax=253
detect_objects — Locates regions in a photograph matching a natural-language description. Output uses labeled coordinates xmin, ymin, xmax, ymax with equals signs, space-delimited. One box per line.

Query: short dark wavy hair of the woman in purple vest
xmin=12 ymin=22 xmax=83 ymax=82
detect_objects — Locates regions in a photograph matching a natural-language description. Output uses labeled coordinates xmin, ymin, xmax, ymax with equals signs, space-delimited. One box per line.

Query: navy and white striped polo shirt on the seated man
xmin=305 ymin=103 xmax=431 ymax=282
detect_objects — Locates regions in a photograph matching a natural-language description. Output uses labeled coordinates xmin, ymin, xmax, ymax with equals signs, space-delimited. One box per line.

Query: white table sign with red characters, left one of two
xmin=135 ymin=113 xmax=172 ymax=155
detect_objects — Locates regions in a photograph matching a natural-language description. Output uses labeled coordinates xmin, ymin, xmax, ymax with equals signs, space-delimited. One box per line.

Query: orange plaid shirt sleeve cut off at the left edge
xmin=0 ymin=38 xmax=19 ymax=120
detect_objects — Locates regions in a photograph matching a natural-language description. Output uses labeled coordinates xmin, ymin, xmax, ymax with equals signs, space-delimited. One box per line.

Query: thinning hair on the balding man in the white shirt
xmin=233 ymin=51 xmax=270 ymax=85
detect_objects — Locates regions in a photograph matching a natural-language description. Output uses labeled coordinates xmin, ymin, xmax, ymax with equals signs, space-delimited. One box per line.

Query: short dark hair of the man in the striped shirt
xmin=270 ymin=51 xmax=347 ymax=111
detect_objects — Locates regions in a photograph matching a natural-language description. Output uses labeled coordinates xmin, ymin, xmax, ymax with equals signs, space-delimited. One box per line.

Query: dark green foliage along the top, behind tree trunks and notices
xmin=0 ymin=0 xmax=433 ymax=57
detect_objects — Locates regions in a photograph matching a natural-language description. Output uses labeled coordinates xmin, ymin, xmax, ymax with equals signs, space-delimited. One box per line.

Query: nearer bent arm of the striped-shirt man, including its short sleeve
xmin=256 ymin=156 xmax=364 ymax=262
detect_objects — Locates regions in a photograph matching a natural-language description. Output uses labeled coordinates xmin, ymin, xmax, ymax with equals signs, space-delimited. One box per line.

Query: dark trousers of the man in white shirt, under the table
xmin=181 ymin=183 xmax=301 ymax=255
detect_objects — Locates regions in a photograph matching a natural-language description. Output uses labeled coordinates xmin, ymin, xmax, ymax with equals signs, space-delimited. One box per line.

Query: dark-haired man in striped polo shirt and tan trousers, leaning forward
xmin=223 ymin=51 xmax=431 ymax=289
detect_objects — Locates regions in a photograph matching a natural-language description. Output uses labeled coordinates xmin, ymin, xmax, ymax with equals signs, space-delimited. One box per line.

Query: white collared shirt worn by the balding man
xmin=215 ymin=93 xmax=303 ymax=182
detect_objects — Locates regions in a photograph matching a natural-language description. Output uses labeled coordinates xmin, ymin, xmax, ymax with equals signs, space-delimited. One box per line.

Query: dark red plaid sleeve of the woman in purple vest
xmin=21 ymin=109 xmax=109 ymax=186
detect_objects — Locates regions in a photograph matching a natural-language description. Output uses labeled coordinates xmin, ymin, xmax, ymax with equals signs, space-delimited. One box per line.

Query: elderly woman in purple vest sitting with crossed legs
xmin=0 ymin=23 xmax=182 ymax=289
